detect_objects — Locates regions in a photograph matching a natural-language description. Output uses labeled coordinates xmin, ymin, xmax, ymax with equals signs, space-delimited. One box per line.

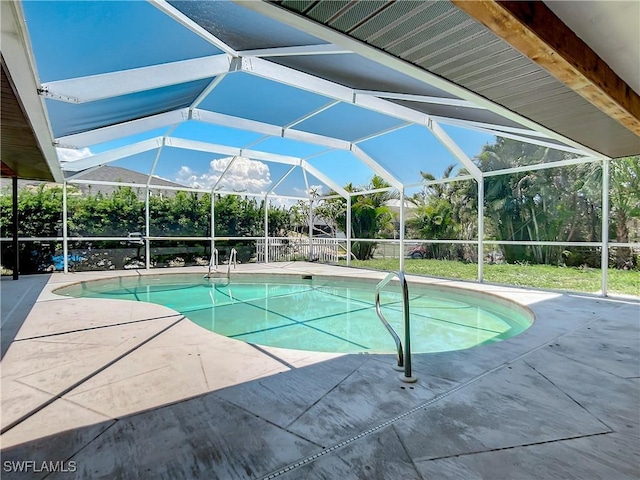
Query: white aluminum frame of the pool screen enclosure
xmin=1 ymin=0 xmax=635 ymax=296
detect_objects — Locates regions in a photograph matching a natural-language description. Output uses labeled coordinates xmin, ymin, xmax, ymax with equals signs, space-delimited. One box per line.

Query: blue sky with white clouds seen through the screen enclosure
xmin=32 ymin=1 xmax=495 ymax=199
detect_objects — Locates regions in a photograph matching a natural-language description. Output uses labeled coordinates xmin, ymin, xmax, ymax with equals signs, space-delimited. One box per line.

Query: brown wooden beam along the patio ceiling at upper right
xmin=451 ymin=0 xmax=640 ymax=136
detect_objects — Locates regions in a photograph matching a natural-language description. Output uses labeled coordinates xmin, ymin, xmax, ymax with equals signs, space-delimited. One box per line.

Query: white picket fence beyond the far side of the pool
xmin=256 ymin=237 xmax=346 ymax=263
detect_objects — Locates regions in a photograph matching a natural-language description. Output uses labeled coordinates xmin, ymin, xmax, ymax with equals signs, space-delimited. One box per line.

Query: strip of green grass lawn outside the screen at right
xmin=341 ymin=258 xmax=640 ymax=296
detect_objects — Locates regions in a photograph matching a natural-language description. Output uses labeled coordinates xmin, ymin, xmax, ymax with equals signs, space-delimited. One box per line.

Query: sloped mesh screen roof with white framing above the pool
xmin=16 ymin=1 xmax=601 ymax=198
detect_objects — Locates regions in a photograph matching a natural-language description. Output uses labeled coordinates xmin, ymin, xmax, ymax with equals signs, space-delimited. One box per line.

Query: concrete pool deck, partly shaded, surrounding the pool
xmin=0 ymin=262 xmax=640 ymax=480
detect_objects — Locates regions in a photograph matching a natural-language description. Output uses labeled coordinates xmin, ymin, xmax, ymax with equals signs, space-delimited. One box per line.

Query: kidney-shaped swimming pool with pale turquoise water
xmin=55 ymin=274 xmax=533 ymax=353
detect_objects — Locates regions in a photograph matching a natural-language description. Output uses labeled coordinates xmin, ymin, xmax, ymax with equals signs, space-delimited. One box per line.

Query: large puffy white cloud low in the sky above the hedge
xmin=175 ymin=157 xmax=272 ymax=193
